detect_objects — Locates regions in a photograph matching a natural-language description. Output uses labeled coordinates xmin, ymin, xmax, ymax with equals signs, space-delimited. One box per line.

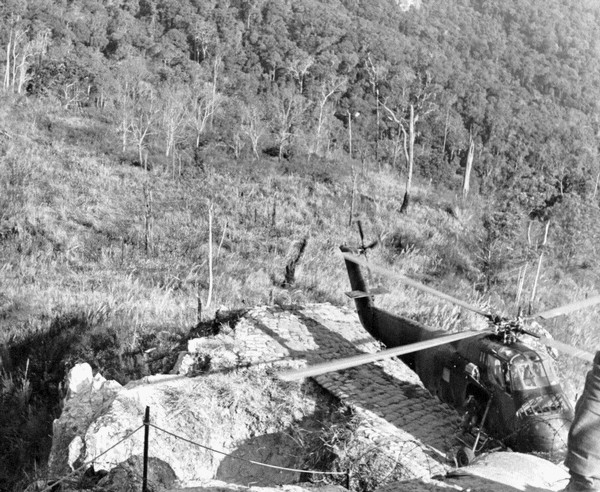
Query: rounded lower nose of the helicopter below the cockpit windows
xmin=519 ymin=415 xmax=571 ymax=459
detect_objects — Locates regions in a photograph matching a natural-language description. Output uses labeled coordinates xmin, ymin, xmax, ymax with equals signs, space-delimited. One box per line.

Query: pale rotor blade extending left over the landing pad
xmin=279 ymin=330 xmax=489 ymax=381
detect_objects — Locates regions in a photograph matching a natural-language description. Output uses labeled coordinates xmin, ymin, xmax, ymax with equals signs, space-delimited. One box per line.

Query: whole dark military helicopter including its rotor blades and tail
xmin=280 ymin=236 xmax=600 ymax=466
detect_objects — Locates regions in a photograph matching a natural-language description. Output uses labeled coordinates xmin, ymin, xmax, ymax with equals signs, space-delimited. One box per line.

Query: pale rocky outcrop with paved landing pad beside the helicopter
xmin=44 ymin=304 xmax=568 ymax=490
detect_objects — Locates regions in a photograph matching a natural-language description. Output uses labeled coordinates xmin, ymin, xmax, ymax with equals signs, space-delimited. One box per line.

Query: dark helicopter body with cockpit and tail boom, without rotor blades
xmin=346 ymin=250 xmax=573 ymax=455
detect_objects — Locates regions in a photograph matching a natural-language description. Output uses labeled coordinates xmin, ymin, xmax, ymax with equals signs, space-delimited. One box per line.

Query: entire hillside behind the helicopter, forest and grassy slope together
xmin=0 ymin=0 xmax=600 ymax=490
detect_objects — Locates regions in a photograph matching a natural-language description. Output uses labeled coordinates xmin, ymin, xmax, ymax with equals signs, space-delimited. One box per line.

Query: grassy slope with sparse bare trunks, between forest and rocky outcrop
xmin=0 ymin=96 xmax=599 ymax=484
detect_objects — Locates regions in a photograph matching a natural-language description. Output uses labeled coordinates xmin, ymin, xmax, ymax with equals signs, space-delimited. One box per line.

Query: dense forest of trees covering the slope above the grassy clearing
xmin=0 ymin=0 xmax=600 ymax=205
